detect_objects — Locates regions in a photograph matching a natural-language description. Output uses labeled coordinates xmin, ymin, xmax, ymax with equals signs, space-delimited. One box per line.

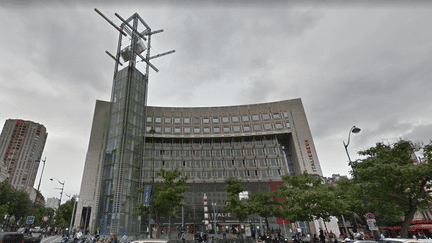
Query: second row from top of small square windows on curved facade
xmin=146 ymin=122 xmax=291 ymax=134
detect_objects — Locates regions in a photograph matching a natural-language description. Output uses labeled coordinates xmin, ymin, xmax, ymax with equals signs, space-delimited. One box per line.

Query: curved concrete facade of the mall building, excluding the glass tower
xmin=75 ymin=99 xmax=322 ymax=233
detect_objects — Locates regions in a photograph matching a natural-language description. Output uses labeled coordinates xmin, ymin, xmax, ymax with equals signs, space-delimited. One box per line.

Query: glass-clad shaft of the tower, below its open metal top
xmin=96 ymin=66 xmax=147 ymax=235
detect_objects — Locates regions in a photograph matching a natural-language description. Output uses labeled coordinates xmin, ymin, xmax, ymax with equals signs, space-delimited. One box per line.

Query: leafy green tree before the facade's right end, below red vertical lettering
xmin=274 ymin=172 xmax=347 ymax=222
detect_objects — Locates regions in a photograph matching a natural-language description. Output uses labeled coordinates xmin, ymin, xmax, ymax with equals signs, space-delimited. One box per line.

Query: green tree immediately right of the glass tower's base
xmin=134 ymin=168 xmax=189 ymax=238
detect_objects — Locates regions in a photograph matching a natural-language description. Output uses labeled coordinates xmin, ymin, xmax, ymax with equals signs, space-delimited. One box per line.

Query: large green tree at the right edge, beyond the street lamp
xmin=353 ymin=140 xmax=432 ymax=238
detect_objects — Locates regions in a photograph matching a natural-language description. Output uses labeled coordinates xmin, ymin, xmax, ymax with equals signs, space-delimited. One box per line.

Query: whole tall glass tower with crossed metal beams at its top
xmin=95 ymin=9 xmax=174 ymax=235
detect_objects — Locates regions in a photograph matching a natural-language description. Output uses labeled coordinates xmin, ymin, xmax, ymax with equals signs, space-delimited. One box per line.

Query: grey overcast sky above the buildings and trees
xmin=0 ymin=1 xmax=432 ymax=202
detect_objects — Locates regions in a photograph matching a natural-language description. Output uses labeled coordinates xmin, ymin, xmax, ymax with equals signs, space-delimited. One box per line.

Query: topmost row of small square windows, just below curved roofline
xmin=146 ymin=111 xmax=288 ymax=124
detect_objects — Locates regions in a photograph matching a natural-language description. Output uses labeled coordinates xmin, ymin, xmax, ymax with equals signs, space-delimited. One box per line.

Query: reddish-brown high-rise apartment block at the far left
xmin=0 ymin=119 xmax=48 ymax=191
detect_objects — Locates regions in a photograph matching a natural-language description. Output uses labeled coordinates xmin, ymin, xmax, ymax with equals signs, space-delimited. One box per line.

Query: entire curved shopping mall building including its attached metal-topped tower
xmin=74 ymin=9 xmax=322 ymax=235
